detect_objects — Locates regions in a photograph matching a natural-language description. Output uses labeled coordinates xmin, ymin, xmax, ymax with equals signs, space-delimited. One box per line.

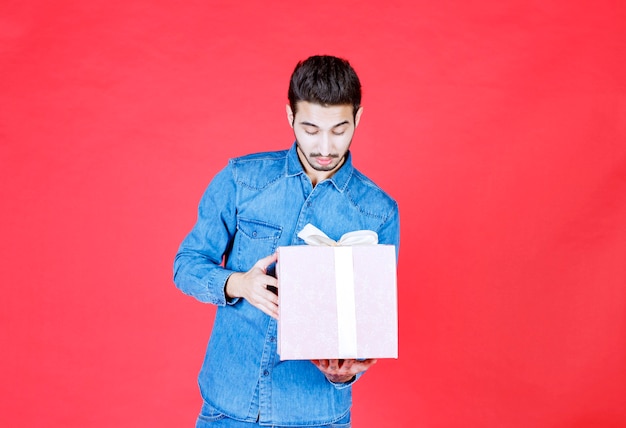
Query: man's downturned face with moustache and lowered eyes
xmin=287 ymin=101 xmax=363 ymax=185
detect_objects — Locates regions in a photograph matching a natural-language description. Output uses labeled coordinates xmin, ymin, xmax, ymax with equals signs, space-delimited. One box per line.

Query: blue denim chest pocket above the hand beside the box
xmin=232 ymin=218 xmax=282 ymax=271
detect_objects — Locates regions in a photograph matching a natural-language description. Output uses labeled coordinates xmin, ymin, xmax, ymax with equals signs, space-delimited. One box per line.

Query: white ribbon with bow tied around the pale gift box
xmin=298 ymin=223 xmax=378 ymax=358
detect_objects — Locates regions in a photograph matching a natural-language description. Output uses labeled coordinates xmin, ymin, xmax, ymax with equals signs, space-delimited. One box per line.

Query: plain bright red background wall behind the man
xmin=0 ymin=0 xmax=626 ymax=428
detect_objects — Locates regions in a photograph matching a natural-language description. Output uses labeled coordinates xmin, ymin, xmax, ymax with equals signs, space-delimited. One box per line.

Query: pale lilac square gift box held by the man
xmin=276 ymin=245 xmax=398 ymax=360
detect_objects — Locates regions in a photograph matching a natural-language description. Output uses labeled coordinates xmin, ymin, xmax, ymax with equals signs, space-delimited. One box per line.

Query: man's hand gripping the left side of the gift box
xmin=225 ymin=253 xmax=278 ymax=319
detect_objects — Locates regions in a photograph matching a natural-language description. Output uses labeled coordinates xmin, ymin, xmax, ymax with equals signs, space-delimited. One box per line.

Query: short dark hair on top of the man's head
xmin=287 ymin=55 xmax=361 ymax=115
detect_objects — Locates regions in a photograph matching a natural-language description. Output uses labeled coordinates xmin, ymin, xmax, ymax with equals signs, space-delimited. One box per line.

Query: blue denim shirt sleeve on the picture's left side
xmin=174 ymin=162 xmax=237 ymax=306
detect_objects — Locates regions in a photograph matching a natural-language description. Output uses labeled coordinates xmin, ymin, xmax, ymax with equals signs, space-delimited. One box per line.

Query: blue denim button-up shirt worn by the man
xmin=174 ymin=144 xmax=399 ymax=426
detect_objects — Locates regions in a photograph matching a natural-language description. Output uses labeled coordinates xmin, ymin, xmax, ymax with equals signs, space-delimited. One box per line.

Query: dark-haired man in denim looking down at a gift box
xmin=174 ymin=56 xmax=399 ymax=428
